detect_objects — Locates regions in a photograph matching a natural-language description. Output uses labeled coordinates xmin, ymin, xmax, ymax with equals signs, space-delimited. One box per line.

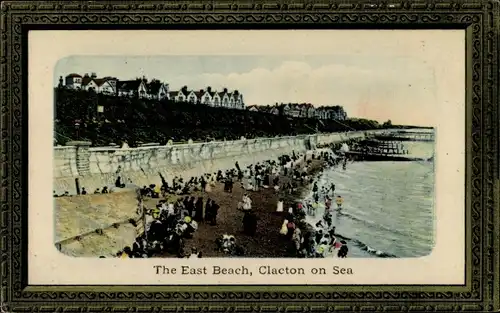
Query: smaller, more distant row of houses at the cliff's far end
xmin=248 ymin=103 xmax=347 ymax=121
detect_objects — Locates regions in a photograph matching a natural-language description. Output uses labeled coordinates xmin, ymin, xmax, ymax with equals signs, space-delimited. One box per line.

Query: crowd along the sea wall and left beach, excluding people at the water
xmin=108 ymin=145 xmax=340 ymax=257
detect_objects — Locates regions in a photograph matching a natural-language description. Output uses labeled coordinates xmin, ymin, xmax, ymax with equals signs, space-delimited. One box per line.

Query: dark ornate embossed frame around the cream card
xmin=1 ymin=0 xmax=500 ymax=312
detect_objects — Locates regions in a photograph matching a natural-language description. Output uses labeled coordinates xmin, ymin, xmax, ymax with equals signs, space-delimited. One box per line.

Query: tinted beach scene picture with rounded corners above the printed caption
xmin=52 ymin=49 xmax=439 ymax=260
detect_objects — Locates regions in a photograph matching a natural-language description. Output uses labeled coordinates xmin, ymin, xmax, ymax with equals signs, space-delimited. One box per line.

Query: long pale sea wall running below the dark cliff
xmin=54 ymin=132 xmax=390 ymax=194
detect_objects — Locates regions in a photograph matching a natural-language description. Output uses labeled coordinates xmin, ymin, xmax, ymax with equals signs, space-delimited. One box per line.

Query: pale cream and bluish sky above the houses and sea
xmin=54 ymin=30 xmax=463 ymax=126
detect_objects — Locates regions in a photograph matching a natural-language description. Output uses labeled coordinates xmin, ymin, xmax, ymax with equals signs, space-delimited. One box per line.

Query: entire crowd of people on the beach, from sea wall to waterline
xmin=97 ymin=139 xmax=358 ymax=258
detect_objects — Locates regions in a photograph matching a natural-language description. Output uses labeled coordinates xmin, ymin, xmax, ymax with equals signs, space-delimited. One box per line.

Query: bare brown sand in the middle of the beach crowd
xmin=145 ymin=160 xmax=324 ymax=258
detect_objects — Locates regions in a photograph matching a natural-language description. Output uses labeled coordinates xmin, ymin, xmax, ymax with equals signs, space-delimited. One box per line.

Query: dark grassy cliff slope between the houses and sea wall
xmin=54 ymin=88 xmax=388 ymax=147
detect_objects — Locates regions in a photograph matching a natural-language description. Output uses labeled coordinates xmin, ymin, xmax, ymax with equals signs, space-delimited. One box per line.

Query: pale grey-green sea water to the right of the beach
xmin=306 ymin=142 xmax=435 ymax=258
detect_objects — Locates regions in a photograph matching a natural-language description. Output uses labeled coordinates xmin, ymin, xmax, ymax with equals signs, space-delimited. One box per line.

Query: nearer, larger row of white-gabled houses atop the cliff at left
xmin=59 ymin=73 xmax=245 ymax=109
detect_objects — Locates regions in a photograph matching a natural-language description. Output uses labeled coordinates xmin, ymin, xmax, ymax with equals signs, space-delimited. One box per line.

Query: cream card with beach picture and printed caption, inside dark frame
xmin=26 ymin=30 xmax=465 ymax=284
